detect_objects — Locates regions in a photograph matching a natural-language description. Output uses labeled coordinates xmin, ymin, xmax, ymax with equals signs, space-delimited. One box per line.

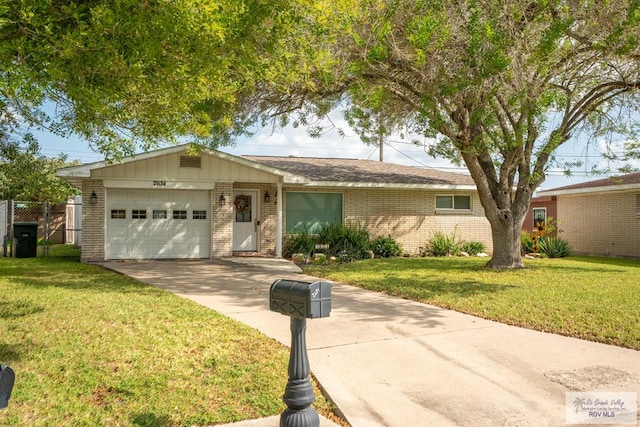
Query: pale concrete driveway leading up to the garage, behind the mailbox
xmin=103 ymin=258 xmax=640 ymax=427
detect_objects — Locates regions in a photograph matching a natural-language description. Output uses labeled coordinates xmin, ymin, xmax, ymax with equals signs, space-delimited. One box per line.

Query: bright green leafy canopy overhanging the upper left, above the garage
xmin=0 ymin=0 xmax=338 ymax=157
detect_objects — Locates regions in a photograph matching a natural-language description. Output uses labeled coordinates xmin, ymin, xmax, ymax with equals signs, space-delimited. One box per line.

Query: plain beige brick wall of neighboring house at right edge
xmin=558 ymin=191 xmax=640 ymax=258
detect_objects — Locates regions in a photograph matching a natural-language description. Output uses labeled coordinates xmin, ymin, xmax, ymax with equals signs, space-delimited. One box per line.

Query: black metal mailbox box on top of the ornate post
xmin=269 ymin=279 xmax=331 ymax=319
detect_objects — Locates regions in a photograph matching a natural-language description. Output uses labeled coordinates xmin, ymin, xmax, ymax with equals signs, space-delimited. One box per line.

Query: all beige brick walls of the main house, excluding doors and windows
xmin=77 ymin=180 xmax=492 ymax=262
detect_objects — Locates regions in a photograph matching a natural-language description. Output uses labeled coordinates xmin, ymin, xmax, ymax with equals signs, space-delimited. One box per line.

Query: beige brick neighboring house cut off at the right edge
xmin=539 ymin=173 xmax=640 ymax=258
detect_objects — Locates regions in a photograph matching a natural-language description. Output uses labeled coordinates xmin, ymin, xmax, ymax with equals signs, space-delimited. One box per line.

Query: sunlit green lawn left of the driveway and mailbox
xmin=0 ymin=246 xmax=340 ymax=426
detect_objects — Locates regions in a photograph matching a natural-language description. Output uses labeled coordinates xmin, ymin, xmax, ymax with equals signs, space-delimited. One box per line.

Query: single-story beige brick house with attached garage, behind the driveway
xmin=58 ymin=146 xmax=491 ymax=262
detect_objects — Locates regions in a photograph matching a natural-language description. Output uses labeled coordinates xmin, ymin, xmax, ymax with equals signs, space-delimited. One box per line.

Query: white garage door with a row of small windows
xmin=106 ymin=189 xmax=211 ymax=259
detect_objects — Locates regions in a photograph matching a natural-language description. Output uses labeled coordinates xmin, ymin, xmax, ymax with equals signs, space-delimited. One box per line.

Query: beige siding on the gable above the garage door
xmin=91 ymin=153 xmax=278 ymax=183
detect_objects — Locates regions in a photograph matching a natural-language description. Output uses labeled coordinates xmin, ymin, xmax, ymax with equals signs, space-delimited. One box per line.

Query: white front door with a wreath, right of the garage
xmin=233 ymin=190 xmax=260 ymax=252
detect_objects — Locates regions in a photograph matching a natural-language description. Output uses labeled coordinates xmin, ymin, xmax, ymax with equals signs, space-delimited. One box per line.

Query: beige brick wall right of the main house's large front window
xmin=288 ymin=188 xmax=493 ymax=254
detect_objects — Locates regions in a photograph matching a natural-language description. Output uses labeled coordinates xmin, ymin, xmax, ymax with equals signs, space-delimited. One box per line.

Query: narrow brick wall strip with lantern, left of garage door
xmin=81 ymin=180 xmax=105 ymax=262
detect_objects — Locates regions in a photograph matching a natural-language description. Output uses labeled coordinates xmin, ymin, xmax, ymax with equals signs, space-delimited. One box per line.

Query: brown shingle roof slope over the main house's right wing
xmin=242 ymin=156 xmax=475 ymax=188
